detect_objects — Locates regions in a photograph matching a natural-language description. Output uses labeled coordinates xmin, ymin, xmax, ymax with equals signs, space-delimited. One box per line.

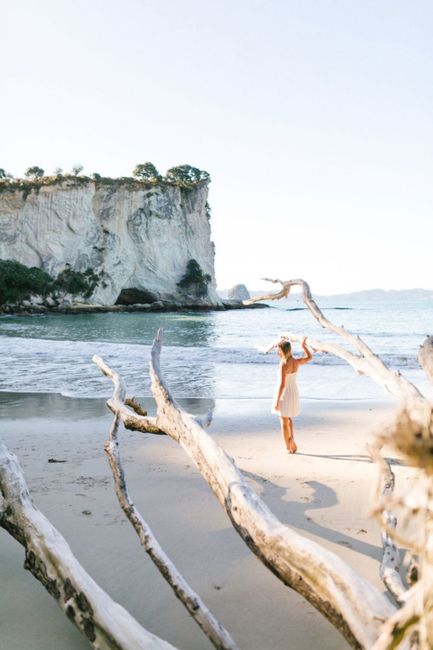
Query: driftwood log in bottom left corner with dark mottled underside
xmin=0 ymin=444 xmax=174 ymax=650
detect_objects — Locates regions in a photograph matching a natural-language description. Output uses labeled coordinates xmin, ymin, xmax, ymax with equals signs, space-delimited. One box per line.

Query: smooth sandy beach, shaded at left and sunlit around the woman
xmin=0 ymin=393 xmax=412 ymax=650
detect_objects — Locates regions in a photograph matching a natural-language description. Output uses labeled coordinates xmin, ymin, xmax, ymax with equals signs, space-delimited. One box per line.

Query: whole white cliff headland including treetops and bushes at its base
xmin=0 ymin=162 xmax=222 ymax=310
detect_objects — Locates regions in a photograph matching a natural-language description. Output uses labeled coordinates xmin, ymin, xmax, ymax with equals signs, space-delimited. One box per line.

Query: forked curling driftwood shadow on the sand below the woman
xmin=242 ymin=470 xmax=382 ymax=561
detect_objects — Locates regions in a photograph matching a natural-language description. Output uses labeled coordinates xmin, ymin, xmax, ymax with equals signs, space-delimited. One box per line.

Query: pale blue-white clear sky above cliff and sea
xmin=0 ymin=0 xmax=433 ymax=294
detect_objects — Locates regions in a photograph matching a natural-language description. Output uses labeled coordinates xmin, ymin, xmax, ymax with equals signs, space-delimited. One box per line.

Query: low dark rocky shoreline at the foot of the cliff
xmin=0 ymin=300 xmax=269 ymax=316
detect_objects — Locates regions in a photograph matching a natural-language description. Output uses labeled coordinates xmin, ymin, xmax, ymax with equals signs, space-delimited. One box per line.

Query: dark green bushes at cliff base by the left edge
xmin=0 ymin=260 xmax=54 ymax=305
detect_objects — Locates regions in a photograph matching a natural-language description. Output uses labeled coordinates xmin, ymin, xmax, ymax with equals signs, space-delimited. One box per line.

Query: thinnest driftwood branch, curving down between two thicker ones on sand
xmin=101 ymin=380 xmax=237 ymax=650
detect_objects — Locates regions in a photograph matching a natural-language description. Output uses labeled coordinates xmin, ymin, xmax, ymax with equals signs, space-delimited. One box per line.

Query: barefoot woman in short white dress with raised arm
xmin=272 ymin=336 xmax=313 ymax=454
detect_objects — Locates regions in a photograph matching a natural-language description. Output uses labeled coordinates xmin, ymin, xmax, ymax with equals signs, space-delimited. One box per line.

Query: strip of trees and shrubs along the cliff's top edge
xmin=0 ymin=162 xmax=210 ymax=199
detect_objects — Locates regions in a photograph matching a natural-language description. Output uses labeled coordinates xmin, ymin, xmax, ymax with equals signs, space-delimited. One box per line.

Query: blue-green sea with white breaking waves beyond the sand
xmin=0 ymin=296 xmax=433 ymax=408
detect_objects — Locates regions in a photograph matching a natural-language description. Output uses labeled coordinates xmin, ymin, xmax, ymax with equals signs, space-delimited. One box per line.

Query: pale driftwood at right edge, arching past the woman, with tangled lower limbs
xmin=246 ymin=279 xmax=433 ymax=649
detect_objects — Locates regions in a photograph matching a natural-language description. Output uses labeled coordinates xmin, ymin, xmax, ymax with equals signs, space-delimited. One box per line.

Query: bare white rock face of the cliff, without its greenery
xmin=0 ymin=182 xmax=221 ymax=305
